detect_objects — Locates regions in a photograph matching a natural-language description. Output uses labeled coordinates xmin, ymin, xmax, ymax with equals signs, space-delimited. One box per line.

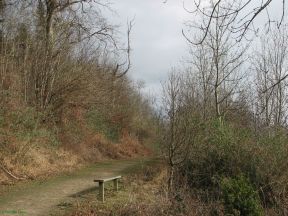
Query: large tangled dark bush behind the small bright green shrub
xmin=179 ymin=118 xmax=288 ymax=210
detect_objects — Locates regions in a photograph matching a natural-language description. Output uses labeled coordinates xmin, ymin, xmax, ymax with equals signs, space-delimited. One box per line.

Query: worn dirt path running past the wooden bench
xmin=0 ymin=160 xmax=148 ymax=216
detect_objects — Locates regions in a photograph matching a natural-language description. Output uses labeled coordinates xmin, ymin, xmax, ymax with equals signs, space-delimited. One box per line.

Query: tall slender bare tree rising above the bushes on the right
xmin=190 ymin=3 xmax=248 ymax=121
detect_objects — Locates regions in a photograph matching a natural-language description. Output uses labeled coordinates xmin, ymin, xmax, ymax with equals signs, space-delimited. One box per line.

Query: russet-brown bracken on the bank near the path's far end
xmin=61 ymin=107 xmax=152 ymax=162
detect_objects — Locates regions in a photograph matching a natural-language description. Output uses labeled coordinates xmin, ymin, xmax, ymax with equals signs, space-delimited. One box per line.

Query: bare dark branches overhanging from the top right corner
xmin=182 ymin=0 xmax=288 ymax=94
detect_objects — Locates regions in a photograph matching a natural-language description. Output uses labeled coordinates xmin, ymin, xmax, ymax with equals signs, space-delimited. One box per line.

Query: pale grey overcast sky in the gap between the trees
xmin=106 ymin=0 xmax=282 ymax=100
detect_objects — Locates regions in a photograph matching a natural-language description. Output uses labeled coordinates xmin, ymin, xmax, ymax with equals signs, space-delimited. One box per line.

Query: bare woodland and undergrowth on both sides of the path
xmin=0 ymin=0 xmax=288 ymax=216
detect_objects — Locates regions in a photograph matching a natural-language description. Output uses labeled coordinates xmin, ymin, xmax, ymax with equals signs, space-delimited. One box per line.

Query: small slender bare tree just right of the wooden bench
xmin=163 ymin=71 xmax=192 ymax=193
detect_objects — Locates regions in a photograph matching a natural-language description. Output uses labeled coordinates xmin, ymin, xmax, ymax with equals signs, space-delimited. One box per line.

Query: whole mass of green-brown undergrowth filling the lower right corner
xmin=171 ymin=120 xmax=288 ymax=216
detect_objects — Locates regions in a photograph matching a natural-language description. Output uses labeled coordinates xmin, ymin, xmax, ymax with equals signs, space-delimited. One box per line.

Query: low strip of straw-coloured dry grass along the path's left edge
xmin=0 ymin=134 xmax=150 ymax=184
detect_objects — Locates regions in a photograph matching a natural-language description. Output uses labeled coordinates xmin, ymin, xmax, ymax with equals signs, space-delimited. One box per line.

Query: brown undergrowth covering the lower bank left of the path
xmin=0 ymin=98 xmax=155 ymax=183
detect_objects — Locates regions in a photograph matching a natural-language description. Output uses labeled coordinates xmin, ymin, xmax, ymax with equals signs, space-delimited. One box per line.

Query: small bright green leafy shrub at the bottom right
xmin=221 ymin=175 xmax=263 ymax=216
